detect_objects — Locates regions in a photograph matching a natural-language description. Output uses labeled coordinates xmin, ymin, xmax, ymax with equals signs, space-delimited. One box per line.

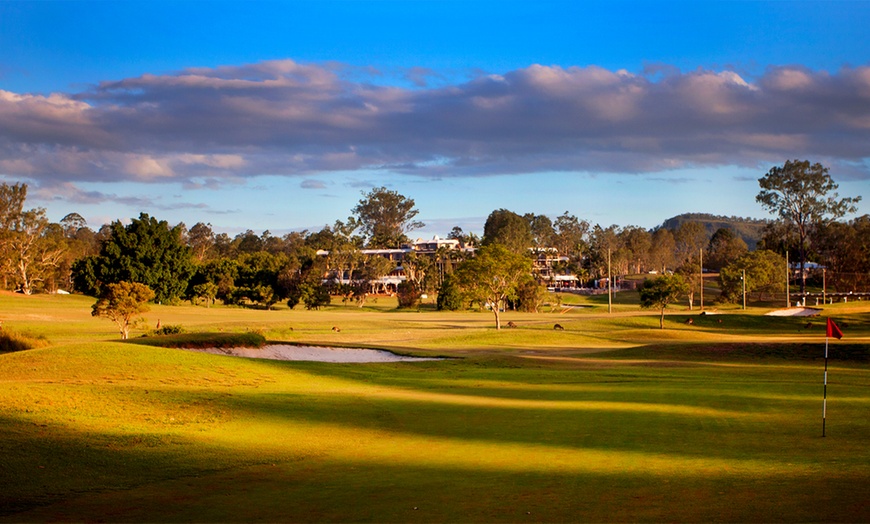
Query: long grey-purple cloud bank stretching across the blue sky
xmin=0 ymin=60 xmax=870 ymax=189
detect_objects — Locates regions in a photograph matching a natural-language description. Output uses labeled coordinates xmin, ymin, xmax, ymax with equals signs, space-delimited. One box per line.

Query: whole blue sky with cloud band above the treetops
xmin=0 ymin=0 xmax=870 ymax=238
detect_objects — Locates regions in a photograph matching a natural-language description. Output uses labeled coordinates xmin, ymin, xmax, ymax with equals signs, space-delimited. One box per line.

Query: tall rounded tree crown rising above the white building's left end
xmin=351 ymin=187 xmax=424 ymax=249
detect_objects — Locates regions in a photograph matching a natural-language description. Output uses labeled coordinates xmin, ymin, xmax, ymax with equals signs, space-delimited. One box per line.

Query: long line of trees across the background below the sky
xmin=0 ymin=161 xmax=870 ymax=322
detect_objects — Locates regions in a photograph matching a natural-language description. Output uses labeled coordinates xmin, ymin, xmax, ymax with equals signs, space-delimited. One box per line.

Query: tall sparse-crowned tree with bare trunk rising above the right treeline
xmin=755 ymin=160 xmax=861 ymax=293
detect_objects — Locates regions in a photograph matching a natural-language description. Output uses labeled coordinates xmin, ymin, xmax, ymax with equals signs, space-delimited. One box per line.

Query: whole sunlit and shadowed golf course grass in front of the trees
xmin=0 ymin=295 xmax=870 ymax=522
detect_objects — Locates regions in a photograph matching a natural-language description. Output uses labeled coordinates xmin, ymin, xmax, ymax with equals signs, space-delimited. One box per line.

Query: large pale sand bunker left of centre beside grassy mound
xmin=182 ymin=344 xmax=443 ymax=363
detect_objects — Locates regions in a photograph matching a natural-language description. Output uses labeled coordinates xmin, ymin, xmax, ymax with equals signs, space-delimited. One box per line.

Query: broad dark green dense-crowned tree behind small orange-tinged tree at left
xmin=73 ymin=213 xmax=194 ymax=302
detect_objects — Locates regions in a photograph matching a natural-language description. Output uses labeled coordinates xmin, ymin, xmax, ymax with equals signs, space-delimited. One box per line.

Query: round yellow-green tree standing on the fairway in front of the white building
xmin=454 ymin=244 xmax=532 ymax=329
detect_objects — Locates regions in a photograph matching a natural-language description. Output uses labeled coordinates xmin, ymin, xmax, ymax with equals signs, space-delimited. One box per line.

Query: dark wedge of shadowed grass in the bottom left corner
xmin=0 ymin=415 xmax=254 ymax=522
